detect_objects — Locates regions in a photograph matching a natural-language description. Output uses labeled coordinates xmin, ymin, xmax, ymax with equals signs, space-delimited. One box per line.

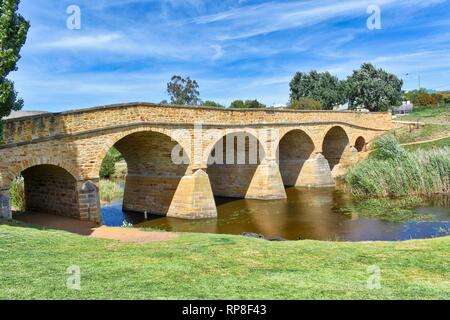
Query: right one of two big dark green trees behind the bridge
xmin=346 ymin=63 xmax=403 ymax=111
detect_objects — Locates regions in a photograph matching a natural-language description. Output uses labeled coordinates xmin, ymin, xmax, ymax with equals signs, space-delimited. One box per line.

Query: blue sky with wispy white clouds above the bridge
xmin=10 ymin=0 xmax=450 ymax=111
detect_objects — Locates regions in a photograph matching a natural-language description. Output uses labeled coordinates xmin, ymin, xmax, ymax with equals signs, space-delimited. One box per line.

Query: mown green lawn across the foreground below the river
xmin=0 ymin=223 xmax=450 ymax=299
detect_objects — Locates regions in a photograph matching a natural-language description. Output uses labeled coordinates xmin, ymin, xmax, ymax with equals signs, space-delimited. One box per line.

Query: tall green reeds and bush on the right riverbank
xmin=345 ymin=136 xmax=450 ymax=197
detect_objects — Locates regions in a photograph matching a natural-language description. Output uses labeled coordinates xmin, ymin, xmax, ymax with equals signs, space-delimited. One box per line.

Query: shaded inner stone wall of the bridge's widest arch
xmin=100 ymin=130 xmax=190 ymax=215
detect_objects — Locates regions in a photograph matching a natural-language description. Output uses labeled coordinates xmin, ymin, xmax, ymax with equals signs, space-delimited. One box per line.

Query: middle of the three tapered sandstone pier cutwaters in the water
xmin=245 ymin=159 xmax=287 ymax=200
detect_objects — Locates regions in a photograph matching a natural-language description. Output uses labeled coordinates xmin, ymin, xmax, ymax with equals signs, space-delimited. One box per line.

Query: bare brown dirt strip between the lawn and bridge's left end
xmin=13 ymin=213 xmax=180 ymax=243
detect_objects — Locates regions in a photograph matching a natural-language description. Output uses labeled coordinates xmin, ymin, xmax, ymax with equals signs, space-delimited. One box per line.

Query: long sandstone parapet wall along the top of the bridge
xmin=3 ymin=103 xmax=392 ymax=144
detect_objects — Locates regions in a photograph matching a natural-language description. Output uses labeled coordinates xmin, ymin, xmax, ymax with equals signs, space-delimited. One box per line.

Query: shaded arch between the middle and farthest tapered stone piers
xmin=277 ymin=129 xmax=315 ymax=186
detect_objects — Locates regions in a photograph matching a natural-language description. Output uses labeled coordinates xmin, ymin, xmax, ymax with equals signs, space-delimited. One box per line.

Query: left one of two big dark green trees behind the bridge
xmin=289 ymin=70 xmax=345 ymax=110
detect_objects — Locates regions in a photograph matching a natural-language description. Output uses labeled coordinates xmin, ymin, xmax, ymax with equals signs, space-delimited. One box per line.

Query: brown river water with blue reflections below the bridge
xmin=103 ymin=188 xmax=450 ymax=241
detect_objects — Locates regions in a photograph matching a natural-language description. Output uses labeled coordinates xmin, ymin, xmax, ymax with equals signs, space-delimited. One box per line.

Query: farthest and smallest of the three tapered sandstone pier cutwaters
xmin=295 ymin=152 xmax=335 ymax=187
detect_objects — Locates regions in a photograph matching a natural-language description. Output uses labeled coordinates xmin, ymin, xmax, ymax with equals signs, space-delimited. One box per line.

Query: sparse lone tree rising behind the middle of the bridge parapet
xmin=167 ymin=76 xmax=201 ymax=106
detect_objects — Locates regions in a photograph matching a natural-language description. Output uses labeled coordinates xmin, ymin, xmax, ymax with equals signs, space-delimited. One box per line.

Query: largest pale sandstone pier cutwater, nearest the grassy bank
xmin=167 ymin=169 xmax=217 ymax=219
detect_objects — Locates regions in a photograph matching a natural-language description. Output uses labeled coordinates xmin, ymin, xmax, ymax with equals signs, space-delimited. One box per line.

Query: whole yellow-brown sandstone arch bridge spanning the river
xmin=0 ymin=103 xmax=392 ymax=223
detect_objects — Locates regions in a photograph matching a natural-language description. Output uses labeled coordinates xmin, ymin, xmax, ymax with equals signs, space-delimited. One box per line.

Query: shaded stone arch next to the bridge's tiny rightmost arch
xmin=322 ymin=126 xmax=350 ymax=171
